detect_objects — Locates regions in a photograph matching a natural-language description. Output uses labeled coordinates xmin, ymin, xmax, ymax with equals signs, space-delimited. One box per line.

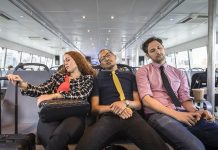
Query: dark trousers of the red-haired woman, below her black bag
xmin=37 ymin=117 xmax=85 ymax=150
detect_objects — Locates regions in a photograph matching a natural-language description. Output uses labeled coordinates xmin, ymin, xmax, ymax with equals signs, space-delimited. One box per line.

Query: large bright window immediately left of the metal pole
xmin=190 ymin=47 xmax=207 ymax=69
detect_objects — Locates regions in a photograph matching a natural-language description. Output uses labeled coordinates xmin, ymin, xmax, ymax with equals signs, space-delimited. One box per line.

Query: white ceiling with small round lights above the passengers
xmin=0 ymin=0 xmax=217 ymax=57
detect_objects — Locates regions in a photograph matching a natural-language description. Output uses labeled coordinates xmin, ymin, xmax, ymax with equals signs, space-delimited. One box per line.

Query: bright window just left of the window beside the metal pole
xmin=176 ymin=51 xmax=189 ymax=70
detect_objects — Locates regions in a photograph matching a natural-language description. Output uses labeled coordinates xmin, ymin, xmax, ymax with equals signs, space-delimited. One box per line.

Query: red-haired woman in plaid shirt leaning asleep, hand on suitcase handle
xmin=7 ymin=51 xmax=95 ymax=150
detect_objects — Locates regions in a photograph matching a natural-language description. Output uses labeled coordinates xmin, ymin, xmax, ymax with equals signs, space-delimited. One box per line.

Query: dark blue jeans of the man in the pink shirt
xmin=148 ymin=113 xmax=218 ymax=150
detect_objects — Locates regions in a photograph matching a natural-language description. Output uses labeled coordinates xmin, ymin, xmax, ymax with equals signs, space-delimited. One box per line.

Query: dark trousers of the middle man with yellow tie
xmin=76 ymin=112 xmax=168 ymax=150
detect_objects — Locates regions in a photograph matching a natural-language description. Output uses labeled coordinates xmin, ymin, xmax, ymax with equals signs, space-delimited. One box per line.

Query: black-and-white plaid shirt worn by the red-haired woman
xmin=21 ymin=73 xmax=94 ymax=99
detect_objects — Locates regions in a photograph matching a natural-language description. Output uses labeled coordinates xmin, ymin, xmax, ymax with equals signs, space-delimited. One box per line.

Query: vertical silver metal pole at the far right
xmin=207 ymin=0 xmax=216 ymax=114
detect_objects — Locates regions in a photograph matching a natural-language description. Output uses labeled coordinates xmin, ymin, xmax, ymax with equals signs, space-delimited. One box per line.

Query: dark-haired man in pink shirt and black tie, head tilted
xmin=136 ymin=37 xmax=218 ymax=150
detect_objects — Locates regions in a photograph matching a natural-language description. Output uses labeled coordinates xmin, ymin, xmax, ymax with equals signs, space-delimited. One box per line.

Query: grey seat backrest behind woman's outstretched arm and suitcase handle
xmin=2 ymin=71 xmax=51 ymax=133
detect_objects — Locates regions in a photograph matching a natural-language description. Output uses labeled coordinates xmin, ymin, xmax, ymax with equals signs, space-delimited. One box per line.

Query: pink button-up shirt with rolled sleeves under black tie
xmin=136 ymin=63 xmax=190 ymax=113
